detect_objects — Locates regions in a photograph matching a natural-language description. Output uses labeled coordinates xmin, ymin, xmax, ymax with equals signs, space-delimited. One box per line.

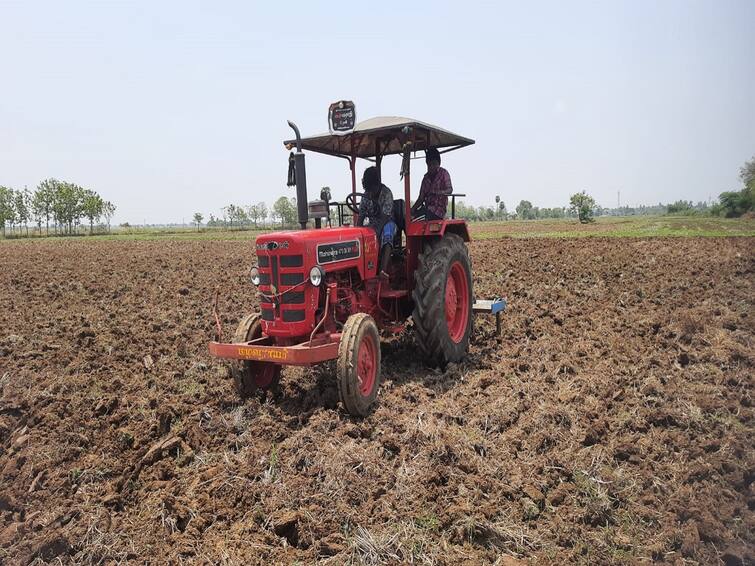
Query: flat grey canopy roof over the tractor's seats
xmin=283 ymin=116 xmax=474 ymax=159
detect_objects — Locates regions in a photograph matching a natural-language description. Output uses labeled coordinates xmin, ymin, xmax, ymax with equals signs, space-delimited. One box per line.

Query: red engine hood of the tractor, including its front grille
xmin=252 ymin=227 xmax=378 ymax=342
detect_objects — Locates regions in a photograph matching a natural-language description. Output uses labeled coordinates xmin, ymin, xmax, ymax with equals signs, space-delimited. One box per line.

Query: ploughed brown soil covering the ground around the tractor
xmin=0 ymin=239 xmax=755 ymax=564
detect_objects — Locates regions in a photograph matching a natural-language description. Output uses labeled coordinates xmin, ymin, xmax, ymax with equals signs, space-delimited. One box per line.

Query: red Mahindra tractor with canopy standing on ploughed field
xmin=209 ymin=103 xmax=505 ymax=416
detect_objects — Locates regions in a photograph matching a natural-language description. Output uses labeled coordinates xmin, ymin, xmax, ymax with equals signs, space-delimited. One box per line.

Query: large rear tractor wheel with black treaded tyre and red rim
xmin=412 ymin=234 xmax=473 ymax=367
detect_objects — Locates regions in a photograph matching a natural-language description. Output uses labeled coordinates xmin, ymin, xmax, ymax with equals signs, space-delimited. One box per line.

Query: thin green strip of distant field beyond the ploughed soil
xmin=0 ymin=216 xmax=755 ymax=242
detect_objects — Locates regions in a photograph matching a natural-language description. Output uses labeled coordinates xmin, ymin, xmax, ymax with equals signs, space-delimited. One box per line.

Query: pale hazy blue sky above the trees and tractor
xmin=0 ymin=0 xmax=755 ymax=223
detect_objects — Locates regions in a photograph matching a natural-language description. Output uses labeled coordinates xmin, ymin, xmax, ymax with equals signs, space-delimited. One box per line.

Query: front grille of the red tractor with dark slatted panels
xmin=257 ymin=255 xmax=306 ymax=322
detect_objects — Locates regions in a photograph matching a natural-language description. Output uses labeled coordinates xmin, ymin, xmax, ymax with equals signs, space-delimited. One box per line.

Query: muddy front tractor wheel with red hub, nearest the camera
xmin=337 ymin=313 xmax=380 ymax=417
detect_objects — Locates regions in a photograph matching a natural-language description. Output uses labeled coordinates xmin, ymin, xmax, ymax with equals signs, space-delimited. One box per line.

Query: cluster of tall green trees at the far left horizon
xmin=0 ymin=179 xmax=115 ymax=237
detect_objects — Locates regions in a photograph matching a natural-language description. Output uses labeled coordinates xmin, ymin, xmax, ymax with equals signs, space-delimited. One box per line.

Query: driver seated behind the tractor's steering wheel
xmin=357 ymin=167 xmax=397 ymax=272
